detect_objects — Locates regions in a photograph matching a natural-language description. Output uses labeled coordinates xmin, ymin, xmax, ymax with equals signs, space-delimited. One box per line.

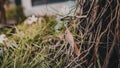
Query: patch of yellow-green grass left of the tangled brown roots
xmin=0 ymin=17 xmax=73 ymax=68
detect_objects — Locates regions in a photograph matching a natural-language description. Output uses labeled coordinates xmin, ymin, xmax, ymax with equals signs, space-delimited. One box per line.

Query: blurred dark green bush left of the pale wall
xmin=6 ymin=6 xmax=26 ymax=23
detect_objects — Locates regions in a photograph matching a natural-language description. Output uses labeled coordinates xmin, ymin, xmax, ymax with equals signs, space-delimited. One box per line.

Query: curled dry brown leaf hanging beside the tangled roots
xmin=65 ymin=29 xmax=80 ymax=55
